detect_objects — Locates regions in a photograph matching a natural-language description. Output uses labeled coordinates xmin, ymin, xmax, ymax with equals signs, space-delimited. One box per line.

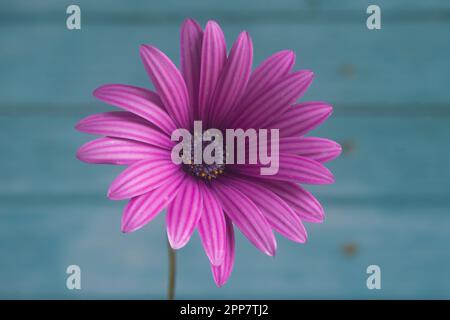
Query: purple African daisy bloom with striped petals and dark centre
xmin=76 ymin=19 xmax=341 ymax=286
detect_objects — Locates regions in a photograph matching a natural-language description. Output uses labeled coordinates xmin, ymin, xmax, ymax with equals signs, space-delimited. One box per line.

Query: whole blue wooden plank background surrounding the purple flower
xmin=0 ymin=0 xmax=450 ymax=299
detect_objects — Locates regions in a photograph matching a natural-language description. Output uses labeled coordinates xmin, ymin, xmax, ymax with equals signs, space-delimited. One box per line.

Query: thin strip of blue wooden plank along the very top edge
xmin=0 ymin=0 xmax=450 ymax=17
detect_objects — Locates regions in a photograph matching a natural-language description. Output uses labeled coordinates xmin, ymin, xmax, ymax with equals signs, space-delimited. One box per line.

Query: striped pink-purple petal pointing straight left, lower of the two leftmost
xmin=77 ymin=137 xmax=167 ymax=165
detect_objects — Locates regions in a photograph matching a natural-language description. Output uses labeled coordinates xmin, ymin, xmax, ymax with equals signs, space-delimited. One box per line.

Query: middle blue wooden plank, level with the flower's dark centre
xmin=0 ymin=114 xmax=450 ymax=201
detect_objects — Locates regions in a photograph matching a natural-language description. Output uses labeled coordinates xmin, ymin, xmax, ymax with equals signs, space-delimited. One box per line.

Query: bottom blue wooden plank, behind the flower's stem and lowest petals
xmin=0 ymin=199 xmax=450 ymax=299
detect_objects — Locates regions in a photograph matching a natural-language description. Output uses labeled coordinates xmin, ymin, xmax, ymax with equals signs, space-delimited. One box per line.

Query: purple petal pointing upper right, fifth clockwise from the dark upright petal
xmin=233 ymin=70 xmax=313 ymax=129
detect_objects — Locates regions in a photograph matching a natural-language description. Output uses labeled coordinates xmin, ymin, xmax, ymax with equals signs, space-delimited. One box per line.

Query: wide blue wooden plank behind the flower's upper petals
xmin=0 ymin=22 xmax=450 ymax=110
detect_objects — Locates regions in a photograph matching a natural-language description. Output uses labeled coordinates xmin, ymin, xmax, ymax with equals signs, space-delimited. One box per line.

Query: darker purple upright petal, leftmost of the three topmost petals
xmin=180 ymin=19 xmax=203 ymax=119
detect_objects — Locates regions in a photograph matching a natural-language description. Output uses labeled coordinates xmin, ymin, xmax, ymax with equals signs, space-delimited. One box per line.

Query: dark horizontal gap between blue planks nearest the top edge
xmin=0 ymin=8 xmax=450 ymax=26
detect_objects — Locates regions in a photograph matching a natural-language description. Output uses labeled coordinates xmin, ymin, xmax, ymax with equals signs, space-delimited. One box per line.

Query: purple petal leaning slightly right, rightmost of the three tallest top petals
xmin=208 ymin=32 xmax=253 ymax=127
